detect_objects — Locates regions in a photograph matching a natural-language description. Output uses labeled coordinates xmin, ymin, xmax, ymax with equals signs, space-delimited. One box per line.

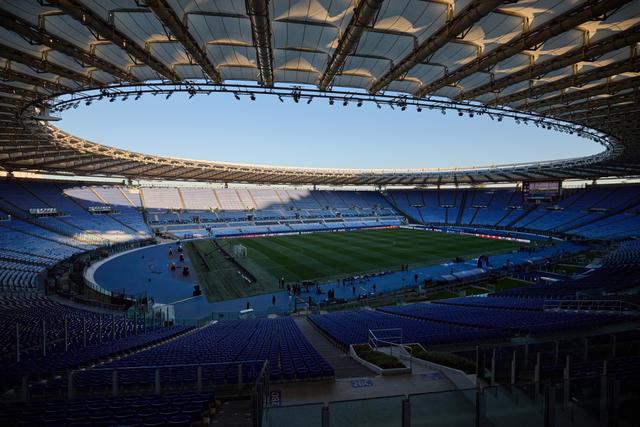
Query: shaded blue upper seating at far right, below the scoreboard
xmin=387 ymin=185 xmax=640 ymax=239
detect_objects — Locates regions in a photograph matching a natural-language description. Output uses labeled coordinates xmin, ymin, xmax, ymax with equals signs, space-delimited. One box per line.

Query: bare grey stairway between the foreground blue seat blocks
xmin=294 ymin=317 xmax=374 ymax=378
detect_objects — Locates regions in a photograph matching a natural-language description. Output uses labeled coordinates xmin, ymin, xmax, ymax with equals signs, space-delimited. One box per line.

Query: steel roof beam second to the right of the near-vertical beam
xmin=369 ymin=0 xmax=503 ymax=94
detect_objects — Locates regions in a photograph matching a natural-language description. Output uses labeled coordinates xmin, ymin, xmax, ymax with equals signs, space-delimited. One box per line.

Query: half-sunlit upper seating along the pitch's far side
xmin=141 ymin=187 xmax=402 ymax=238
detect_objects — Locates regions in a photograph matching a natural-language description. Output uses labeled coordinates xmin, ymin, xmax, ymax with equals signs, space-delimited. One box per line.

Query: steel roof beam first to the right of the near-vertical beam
xmin=318 ymin=0 xmax=384 ymax=90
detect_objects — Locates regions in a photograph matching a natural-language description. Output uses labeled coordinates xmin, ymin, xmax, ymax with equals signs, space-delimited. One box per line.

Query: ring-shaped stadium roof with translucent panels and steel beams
xmin=0 ymin=0 xmax=640 ymax=185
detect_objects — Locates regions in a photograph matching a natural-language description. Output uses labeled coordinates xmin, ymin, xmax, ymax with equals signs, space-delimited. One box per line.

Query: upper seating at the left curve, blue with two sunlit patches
xmin=0 ymin=180 xmax=151 ymax=293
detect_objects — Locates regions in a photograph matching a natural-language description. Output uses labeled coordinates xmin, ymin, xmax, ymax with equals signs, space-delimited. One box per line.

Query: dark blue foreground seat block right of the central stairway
xmin=309 ymin=298 xmax=625 ymax=348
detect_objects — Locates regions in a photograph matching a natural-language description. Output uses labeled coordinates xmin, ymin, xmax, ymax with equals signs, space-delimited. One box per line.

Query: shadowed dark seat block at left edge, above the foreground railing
xmin=0 ymin=296 xmax=188 ymax=383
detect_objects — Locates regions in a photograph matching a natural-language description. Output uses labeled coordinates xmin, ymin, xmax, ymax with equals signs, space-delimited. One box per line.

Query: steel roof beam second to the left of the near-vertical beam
xmin=49 ymin=0 xmax=180 ymax=82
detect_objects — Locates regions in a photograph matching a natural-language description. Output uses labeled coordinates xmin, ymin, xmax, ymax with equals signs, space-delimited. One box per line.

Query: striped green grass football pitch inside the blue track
xmin=187 ymin=228 xmax=521 ymax=301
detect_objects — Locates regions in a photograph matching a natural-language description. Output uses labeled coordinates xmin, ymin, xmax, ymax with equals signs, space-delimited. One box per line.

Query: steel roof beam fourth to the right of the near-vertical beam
xmin=454 ymin=25 xmax=640 ymax=101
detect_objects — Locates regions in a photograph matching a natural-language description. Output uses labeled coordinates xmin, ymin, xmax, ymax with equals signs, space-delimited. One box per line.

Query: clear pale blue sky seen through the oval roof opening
xmin=59 ymin=94 xmax=601 ymax=168
